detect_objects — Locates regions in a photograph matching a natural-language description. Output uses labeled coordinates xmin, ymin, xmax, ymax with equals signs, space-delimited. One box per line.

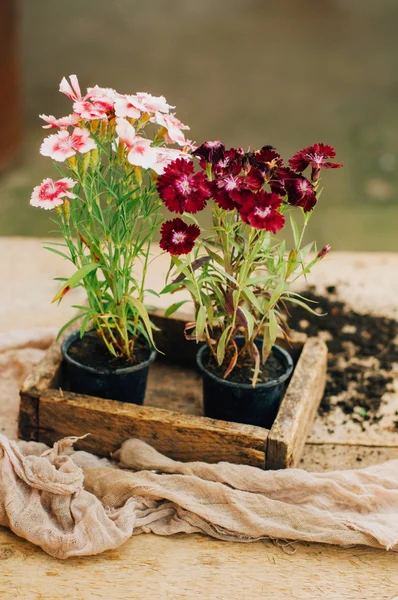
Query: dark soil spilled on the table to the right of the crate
xmin=288 ymin=286 xmax=398 ymax=425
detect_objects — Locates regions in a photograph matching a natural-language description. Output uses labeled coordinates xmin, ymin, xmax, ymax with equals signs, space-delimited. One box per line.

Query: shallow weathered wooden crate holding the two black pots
xmin=19 ymin=311 xmax=327 ymax=469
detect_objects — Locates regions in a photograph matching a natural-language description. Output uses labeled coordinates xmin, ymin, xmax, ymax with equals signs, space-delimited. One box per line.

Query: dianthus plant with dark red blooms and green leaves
xmin=157 ymin=142 xmax=341 ymax=386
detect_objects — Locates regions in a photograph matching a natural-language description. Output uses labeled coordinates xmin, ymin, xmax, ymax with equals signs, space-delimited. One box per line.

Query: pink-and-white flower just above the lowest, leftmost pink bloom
xmin=40 ymin=127 xmax=97 ymax=162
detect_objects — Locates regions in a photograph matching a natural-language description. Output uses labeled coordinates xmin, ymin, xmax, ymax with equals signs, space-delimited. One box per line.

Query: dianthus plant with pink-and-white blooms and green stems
xmin=30 ymin=75 xmax=190 ymax=359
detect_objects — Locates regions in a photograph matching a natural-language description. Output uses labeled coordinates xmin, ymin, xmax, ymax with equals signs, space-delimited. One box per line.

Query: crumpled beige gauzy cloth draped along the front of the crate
xmin=0 ymin=328 xmax=398 ymax=558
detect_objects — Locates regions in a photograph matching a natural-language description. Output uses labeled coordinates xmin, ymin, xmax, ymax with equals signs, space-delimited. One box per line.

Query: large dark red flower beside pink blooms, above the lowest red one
xmin=157 ymin=158 xmax=211 ymax=215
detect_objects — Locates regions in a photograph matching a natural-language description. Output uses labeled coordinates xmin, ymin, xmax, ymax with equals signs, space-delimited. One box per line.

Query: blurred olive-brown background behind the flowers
xmin=0 ymin=0 xmax=398 ymax=251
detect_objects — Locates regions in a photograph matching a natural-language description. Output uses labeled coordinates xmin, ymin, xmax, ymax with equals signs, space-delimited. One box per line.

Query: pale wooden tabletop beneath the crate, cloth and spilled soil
xmin=0 ymin=238 xmax=398 ymax=600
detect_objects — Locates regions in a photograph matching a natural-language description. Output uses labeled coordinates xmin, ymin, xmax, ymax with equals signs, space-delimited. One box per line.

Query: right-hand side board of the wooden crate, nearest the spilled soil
xmin=266 ymin=338 xmax=327 ymax=469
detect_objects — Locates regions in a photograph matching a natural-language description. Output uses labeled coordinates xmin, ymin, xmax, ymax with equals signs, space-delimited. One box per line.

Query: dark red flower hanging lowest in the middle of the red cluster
xmin=239 ymin=190 xmax=285 ymax=233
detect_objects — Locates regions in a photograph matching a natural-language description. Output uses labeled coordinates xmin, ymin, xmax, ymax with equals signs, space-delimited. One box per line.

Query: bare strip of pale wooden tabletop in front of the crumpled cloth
xmin=0 ymin=528 xmax=398 ymax=600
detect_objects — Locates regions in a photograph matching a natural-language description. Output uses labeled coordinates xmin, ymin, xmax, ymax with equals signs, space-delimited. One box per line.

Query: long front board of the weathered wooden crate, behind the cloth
xmin=39 ymin=389 xmax=268 ymax=467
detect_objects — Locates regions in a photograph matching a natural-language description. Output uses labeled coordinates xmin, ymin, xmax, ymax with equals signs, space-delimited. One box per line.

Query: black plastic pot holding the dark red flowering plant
xmin=196 ymin=337 xmax=293 ymax=429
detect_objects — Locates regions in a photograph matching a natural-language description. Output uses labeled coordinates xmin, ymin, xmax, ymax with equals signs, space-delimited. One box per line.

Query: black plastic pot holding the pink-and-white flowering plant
xmin=61 ymin=331 xmax=156 ymax=404
